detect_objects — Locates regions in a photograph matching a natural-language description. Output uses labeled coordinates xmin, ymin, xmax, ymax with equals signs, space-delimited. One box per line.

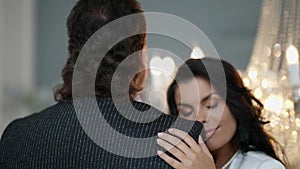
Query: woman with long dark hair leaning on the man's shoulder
xmin=157 ymin=58 xmax=288 ymax=169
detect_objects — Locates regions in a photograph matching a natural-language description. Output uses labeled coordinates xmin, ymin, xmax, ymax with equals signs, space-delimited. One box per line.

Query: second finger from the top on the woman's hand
xmin=158 ymin=133 xmax=191 ymax=154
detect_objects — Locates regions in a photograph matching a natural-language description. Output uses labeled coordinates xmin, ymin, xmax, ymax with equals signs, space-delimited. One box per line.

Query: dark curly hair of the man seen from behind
xmin=54 ymin=0 xmax=146 ymax=101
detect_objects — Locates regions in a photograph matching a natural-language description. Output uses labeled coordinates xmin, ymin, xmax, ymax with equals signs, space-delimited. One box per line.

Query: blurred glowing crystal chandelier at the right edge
xmin=243 ymin=0 xmax=300 ymax=166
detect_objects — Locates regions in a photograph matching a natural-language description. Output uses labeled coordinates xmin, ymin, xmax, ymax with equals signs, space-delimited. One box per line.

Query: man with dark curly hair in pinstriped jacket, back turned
xmin=0 ymin=0 xmax=201 ymax=169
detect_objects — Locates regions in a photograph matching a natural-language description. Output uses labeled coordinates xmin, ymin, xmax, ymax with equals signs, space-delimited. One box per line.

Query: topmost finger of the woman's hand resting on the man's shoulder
xmin=168 ymin=128 xmax=200 ymax=151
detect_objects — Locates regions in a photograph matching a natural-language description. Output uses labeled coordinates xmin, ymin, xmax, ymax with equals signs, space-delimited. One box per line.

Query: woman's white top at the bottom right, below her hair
xmin=229 ymin=151 xmax=285 ymax=169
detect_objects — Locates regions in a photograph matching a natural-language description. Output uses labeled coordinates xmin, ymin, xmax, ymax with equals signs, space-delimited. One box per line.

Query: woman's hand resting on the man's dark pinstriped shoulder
xmin=157 ymin=129 xmax=216 ymax=169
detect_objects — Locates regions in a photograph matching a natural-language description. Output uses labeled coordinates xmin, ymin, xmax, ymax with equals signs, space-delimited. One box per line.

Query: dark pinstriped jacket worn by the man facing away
xmin=0 ymin=99 xmax=202 ymax=169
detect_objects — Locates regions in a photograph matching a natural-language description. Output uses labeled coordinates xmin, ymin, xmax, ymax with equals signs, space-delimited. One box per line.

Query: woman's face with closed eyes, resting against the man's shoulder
xmin=175 ymin=78 xmax=237 ymax=151
